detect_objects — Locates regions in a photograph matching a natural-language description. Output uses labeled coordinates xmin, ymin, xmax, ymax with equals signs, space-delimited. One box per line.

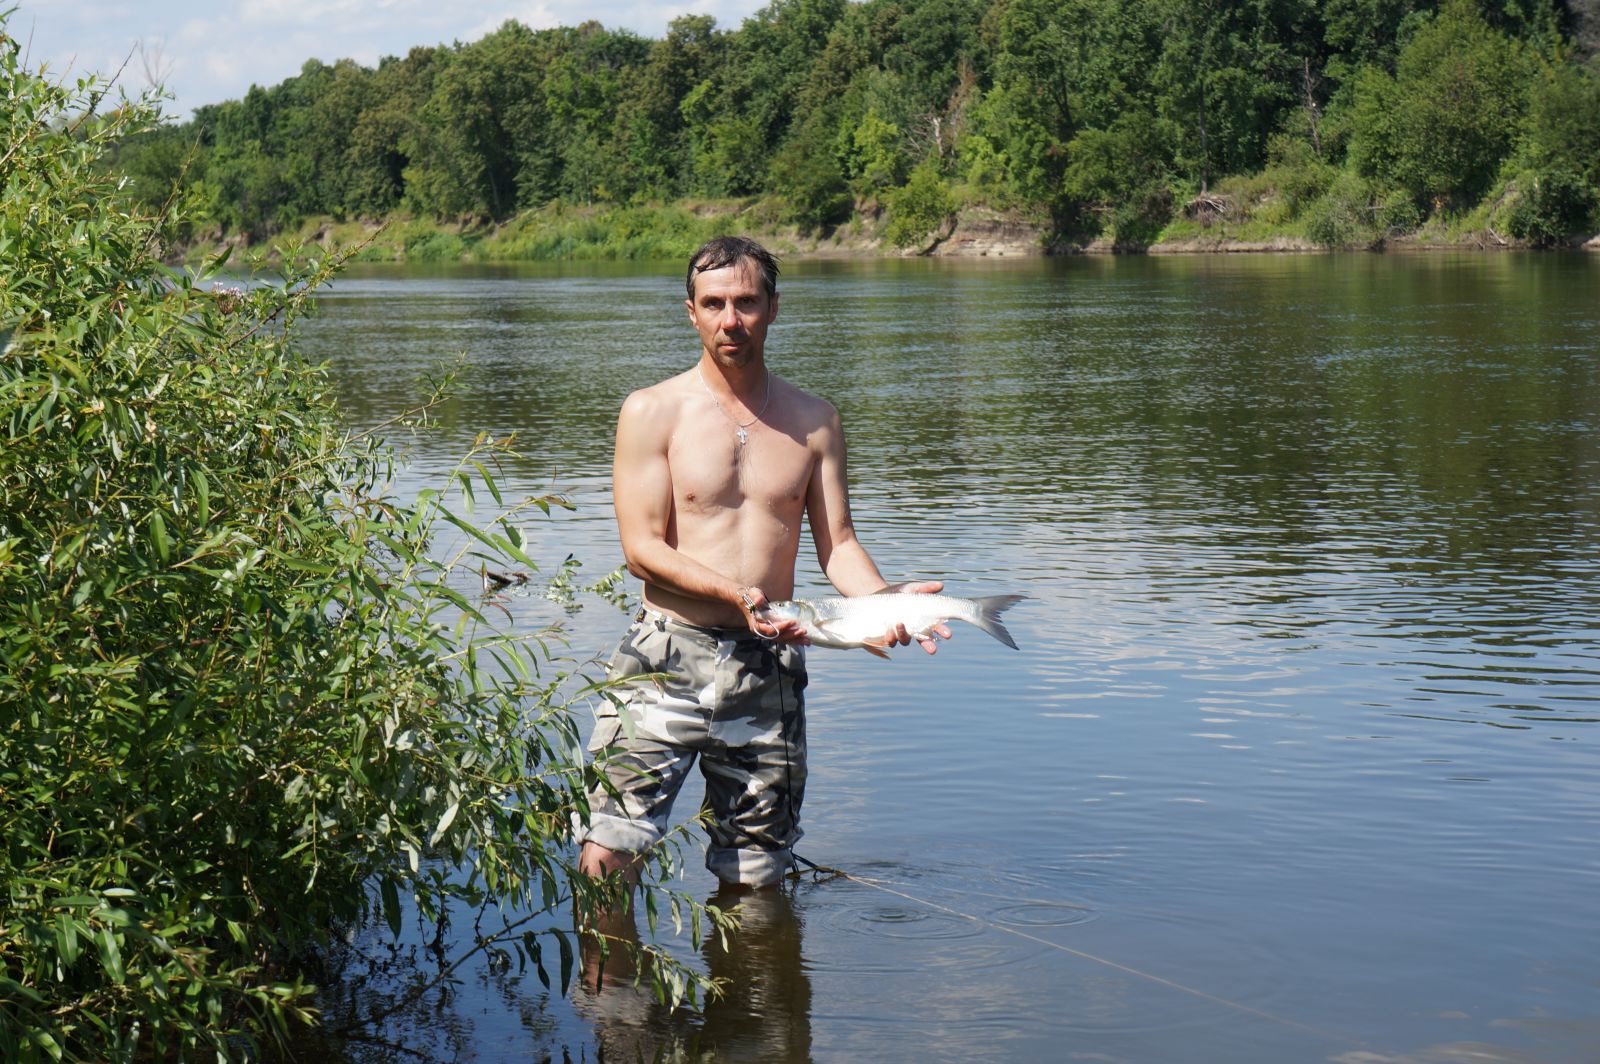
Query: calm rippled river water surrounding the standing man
xmin=291 ymin=253 xmax=1600 ymax=1064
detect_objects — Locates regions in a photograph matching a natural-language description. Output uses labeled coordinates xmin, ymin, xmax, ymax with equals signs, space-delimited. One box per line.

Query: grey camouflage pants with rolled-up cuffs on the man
xmin=579 ymin=610 xmax=806 ymax=886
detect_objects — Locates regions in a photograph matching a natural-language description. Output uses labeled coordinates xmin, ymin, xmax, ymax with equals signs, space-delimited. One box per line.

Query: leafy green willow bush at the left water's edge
xmin=0 ymin=27 xmax=720 ymax=1061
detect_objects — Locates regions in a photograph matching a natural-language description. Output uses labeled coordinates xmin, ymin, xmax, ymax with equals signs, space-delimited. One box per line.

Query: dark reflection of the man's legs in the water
xmin=573 ymin=890 xmax=811 ymax=1061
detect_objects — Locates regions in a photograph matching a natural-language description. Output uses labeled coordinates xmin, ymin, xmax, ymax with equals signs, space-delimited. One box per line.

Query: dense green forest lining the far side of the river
xmin=112 ymin=0 xmax=1600 ymax=246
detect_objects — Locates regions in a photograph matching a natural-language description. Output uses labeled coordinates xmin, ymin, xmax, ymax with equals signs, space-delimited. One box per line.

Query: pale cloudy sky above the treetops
xmin=10 ymin=0 xmax=766 ymax=118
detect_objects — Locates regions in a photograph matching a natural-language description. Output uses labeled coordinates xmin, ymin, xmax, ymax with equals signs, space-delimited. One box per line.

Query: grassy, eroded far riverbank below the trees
xmin=190 ymin=200 xmax=1600 ymax=262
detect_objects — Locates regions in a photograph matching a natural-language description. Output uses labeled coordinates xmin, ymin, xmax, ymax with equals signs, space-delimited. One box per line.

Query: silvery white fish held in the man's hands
xmin=758 ymin=592 xmax=1027 ymax=658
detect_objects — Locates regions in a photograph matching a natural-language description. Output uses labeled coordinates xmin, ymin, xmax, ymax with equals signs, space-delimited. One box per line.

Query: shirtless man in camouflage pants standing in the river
xmin=579 ymin=237 xmax=950 ymax=886
